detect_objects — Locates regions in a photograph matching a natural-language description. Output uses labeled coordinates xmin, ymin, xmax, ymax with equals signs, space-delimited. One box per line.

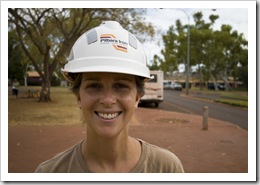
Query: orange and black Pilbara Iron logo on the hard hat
xmin=100 ymin=34 xmax=128 ymax=52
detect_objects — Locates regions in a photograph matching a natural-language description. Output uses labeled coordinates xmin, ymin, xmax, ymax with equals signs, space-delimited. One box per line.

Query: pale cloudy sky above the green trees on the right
xmin=143 ymin=6 xmax=248 ymax=71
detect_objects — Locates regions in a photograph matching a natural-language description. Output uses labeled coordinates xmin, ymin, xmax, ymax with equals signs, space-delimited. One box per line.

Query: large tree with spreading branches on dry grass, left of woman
xmin=8 ymin=8 xmax=154 ymax=102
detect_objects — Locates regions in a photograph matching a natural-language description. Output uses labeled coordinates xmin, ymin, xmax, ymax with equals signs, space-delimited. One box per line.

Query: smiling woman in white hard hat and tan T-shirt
xmin=36 ymin=21 xmax=184 ymax=173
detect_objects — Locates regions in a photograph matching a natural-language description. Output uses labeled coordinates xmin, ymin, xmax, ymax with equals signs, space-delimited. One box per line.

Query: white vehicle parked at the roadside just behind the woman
xmin=140 ymin=71 xmax=163 ymax=107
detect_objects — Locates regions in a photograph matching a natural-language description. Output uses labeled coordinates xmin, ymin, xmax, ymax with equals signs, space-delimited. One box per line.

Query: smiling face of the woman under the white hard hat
xmin=78 ymin=73 xmax=140 ymax=138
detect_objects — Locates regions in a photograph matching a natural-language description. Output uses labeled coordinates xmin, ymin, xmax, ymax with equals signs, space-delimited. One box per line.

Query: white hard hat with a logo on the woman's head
xmin=61 ymin=21 xmax=150 ymax=82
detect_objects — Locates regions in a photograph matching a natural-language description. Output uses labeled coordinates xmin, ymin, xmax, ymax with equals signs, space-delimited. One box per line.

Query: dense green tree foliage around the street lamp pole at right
xmin=157 ymin=12 xmax=248 ymax=88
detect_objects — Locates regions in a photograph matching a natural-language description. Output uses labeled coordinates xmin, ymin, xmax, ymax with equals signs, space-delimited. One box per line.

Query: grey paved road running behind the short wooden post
xmin=140 ymin=90 xmax=248 ymax=130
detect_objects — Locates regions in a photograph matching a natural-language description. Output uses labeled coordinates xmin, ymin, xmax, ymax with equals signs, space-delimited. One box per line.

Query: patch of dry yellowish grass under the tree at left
xmin=8 ymin=87 xmax=82 ymax=125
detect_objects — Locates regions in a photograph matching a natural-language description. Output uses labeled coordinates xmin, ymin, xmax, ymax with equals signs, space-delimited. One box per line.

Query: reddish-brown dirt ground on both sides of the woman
xmin=8 ymin=108 xmax=248 ymax=173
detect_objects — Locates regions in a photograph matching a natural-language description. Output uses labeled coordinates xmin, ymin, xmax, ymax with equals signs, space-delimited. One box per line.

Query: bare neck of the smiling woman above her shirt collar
xmin=82 ymin=132 xmax=141 ymax=172
